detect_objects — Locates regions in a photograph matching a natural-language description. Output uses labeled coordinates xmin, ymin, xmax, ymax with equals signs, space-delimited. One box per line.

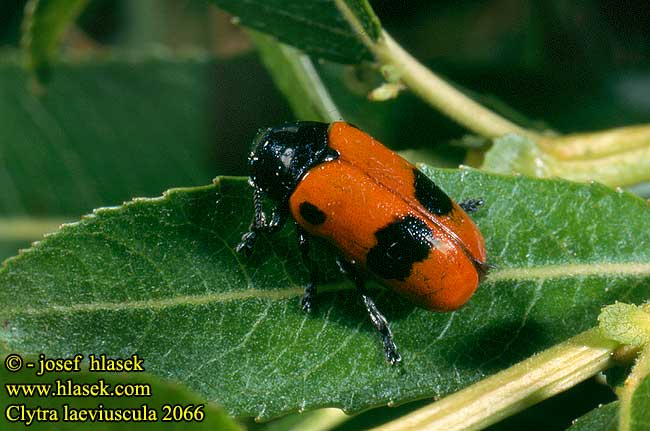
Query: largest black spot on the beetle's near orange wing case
xmin=366 ymin=216 xmax=433 ymax=280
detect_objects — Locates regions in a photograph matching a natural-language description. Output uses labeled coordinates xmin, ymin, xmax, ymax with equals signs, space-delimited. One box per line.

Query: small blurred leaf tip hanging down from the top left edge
xmin=22 ymin=0 xmax=88 ymax=82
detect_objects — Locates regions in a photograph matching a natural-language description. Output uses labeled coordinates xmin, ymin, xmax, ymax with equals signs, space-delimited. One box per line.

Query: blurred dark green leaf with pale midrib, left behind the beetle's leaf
xmin=0 ymin=55 xmax=221 ymax=260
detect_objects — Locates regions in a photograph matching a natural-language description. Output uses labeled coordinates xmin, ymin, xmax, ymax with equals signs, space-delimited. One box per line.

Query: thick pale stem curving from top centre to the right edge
xmin=335 ymin=0 xmax=650 ymax=186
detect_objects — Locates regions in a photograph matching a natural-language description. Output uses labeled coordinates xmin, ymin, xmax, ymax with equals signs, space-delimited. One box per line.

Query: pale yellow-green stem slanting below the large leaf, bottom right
xmin=374 ymin=328 xmax=619 ymax=431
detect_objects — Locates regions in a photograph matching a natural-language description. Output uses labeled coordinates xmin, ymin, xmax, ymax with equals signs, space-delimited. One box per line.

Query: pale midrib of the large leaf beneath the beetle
xmin=2 ymin=262 xmax=650 ymax=318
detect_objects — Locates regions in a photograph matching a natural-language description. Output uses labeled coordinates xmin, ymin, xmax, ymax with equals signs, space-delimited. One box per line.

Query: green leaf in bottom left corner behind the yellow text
xmin=0 ymin=362 xmax=242 ymax=431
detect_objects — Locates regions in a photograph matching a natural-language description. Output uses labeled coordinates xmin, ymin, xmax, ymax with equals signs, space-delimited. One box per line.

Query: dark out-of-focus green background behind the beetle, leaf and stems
xmin=0 ymin=0 xmax=650 ymax=429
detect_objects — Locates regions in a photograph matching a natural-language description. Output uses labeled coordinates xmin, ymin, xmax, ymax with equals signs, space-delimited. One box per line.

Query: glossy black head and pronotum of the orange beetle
xmin=248 ymin=121 xmax=338 ymax=202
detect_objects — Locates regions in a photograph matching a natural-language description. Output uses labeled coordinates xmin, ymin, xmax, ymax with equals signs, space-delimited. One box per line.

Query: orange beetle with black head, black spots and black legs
xmin=236 ymin=121 xmax=489 ymax=365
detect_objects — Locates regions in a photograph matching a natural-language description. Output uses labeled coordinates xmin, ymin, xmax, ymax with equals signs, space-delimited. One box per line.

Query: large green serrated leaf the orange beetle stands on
xmin=0 ymin=167 xmax=650 ymax=418
